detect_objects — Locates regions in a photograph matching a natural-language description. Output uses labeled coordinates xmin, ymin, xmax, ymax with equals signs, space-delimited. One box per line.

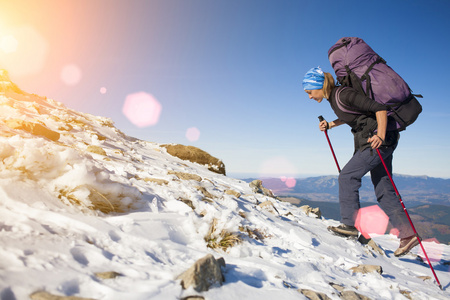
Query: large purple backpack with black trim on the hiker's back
xmin=328 ymin=37 xmax=422 ymax=131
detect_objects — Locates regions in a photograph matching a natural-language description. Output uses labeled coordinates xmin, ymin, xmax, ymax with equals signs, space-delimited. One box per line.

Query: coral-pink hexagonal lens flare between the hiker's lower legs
xmin=355 ymin=205 xmax=389 ymax=239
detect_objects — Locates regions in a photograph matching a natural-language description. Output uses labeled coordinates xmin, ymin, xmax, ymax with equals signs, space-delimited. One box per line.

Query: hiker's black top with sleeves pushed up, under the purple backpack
xmin=328 ymin=87 xmax=398 ymax=152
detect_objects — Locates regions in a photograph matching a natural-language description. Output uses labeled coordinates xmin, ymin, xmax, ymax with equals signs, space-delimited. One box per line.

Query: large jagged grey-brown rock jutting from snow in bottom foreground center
xmin=177 ymin=254 xmax=224 ymax=292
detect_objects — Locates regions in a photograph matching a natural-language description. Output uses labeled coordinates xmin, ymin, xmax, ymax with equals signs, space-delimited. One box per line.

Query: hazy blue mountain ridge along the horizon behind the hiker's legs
xmin=243 ymin=174 xmax=450 ymax=206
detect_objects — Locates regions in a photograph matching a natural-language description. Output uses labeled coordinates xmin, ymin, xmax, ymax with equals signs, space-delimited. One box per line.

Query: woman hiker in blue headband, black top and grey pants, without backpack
xmin=303 ymin=67 xmax=419 ymax=256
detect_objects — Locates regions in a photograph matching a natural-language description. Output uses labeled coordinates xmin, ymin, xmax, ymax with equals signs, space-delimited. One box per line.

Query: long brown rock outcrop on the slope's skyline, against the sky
xmin=161 ymin=144 xmax=226 ymax=175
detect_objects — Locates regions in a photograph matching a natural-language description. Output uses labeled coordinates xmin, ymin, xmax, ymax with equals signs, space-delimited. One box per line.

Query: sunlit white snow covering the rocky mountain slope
xmin=0 ymin=78 xmax=450 ymax=300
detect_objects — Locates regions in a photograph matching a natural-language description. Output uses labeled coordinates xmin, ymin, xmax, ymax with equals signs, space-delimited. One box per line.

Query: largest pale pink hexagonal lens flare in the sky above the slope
xmin=122 ymin=92 xmax=162 ymax=128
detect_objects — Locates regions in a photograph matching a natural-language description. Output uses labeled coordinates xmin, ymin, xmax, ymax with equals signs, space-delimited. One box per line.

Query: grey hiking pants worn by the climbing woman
xmin=339 ymin=144 xmax=414 ymax=238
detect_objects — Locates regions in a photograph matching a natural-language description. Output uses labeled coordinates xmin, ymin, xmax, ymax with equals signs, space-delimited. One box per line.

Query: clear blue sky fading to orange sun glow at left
xmin=0 ymin=0 xmax=450 ymax=178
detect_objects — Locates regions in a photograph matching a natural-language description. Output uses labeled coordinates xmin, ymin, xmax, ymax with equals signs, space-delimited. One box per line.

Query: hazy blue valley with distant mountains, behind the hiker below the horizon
xmin=245 ymin=174 xmax=450 ymax=244
